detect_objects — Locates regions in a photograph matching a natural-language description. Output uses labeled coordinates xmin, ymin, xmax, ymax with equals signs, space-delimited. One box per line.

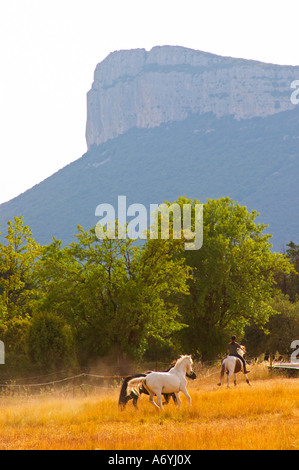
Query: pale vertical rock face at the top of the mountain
xmin=86 ymin=46 xmax=299 ymax=149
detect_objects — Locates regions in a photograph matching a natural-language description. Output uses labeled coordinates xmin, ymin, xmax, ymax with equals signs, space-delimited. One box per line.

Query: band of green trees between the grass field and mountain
xmin=0 ymin=197 xmax=299 ymax=375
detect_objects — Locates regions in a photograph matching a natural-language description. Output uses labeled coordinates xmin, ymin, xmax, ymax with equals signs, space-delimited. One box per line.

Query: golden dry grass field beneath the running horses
xmin=0 ymin=366 xmax=299 ymax=450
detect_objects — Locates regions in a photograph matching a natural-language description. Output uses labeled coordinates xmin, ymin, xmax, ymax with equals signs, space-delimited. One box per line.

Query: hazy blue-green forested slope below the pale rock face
xmin=0 ymin=109 xmax=299 ymax=251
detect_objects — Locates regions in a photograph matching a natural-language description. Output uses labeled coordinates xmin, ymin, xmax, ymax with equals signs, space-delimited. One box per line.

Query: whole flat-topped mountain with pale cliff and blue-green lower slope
xmin=0 ymin=47 xmax=299 ymax=251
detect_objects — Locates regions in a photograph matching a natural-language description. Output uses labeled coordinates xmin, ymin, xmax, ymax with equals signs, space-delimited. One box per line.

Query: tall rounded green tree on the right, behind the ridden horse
xmin=178 ymin=198 xmax=290 ymax=359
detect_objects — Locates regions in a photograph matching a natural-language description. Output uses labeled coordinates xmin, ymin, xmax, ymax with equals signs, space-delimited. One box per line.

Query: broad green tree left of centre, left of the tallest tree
xmin=39 ymin=226 xmax=189 ymax=363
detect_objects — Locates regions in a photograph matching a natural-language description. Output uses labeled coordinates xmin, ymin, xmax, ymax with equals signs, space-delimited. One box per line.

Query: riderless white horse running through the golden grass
xmin=127 ymin=356 xmax=193 ymax=410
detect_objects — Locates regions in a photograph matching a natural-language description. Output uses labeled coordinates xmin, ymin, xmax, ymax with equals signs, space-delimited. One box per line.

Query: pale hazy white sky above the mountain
xmin=0 ymin=0 xmax=299 ymax=205
